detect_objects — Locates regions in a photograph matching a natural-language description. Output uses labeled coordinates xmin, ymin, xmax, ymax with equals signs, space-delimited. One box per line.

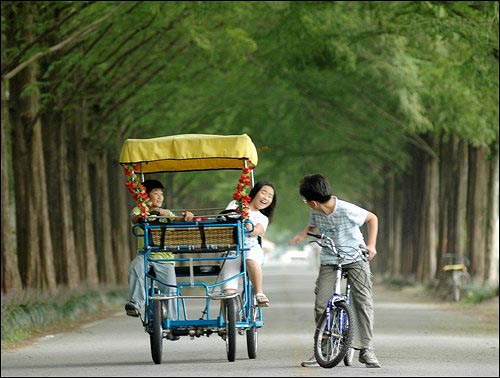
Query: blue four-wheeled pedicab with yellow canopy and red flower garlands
xmin=120 ymin=134 xmax=264 ymax=364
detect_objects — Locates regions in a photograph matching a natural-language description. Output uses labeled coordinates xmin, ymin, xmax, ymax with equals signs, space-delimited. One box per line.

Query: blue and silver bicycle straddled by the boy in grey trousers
xmin=307 ymin=232 xmax=368 ymax=368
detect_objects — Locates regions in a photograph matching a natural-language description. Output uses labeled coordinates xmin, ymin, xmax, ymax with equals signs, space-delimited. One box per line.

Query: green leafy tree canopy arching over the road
xmin=2 ymin=1 xmax=498 ymax=239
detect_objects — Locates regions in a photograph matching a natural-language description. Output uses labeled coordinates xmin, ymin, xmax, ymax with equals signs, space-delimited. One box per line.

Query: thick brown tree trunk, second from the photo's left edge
xmin=10 ymin=3 xmax=56 ymax=289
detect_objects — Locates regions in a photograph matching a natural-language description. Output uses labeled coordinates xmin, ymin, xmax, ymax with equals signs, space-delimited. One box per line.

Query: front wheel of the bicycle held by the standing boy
xmin=314 ymin=301 xmax=354 ymax=368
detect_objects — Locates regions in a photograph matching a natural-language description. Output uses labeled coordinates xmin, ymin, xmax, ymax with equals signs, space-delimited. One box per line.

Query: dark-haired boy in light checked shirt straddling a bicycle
xmin=289 ymin=174 xmax=380 ymax=368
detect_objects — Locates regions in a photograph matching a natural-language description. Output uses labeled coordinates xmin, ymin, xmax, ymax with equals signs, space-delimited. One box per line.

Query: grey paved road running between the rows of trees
xmin=1 ymin=264 xmax=499 ymax=377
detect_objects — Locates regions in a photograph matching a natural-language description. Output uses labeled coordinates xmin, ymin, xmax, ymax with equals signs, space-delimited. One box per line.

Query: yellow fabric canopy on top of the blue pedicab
xmin=120 ymin=134 xmax=258 ymax=173
